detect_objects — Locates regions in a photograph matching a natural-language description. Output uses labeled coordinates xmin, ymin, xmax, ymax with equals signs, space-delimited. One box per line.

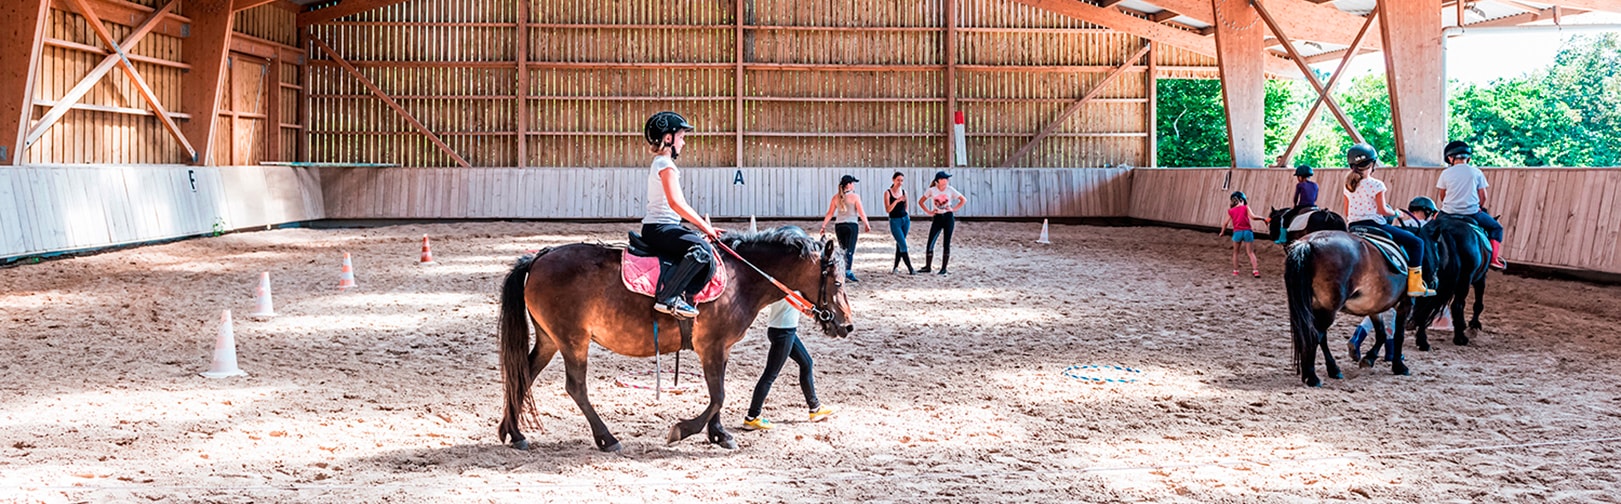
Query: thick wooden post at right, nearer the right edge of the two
xmin=1379 ymin=0 xmax=1446 ymax=167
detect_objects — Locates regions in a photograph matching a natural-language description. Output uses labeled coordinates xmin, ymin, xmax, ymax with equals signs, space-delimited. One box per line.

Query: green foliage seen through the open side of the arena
xmin=1159 ymin=34 xmax=1621 ymax=167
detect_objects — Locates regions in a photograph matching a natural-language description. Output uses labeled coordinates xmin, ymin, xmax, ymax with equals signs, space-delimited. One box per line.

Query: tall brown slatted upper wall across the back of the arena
xmin=306 ymin=0 xmax=1214 ymax=167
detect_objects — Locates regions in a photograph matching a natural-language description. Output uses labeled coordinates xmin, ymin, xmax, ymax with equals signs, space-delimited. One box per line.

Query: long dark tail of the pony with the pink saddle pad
xmin=498 ymin=251 xmax=545 ymax=442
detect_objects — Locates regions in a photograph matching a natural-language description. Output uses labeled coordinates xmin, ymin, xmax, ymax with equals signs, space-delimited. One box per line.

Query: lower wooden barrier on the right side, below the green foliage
xmin=1130 ymin=169 xmax=1621 ymax=272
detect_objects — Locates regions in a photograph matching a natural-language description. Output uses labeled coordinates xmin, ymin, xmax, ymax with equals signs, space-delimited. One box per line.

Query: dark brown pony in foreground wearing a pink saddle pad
xmin=499 ymin=227 xmax=854 ymax=452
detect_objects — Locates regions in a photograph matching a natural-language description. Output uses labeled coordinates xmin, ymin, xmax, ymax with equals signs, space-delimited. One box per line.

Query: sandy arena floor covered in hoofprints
xmin=0 ymin=222 xmax=1621 ymax=502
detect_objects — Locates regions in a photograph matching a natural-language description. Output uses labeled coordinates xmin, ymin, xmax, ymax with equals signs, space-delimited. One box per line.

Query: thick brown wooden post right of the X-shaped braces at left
xmin=180 ymin=0 xmax=236 ymax=165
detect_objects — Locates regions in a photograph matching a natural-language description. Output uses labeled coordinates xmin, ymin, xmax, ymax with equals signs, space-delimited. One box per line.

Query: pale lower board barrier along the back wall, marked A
xmin=312 ymin=167 xmax=1131 ymax=219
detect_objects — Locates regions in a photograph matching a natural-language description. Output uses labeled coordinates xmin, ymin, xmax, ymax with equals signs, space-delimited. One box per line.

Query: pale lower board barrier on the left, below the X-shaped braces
xmin=0 ymin=165 xmax=326 ymax=259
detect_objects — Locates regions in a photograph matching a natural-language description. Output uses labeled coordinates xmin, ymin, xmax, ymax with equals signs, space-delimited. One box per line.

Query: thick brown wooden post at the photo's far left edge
xmin=0 ymin=0 xmax=50 ymax=165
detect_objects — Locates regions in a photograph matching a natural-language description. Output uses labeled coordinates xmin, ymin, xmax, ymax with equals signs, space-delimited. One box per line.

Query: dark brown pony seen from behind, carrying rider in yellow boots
xmin=1284 ymin=230 xmax=1412 ymax=387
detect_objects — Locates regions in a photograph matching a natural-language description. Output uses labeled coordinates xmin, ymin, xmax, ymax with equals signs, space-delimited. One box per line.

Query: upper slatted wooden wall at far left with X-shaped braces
xmin=19 ymin=0 xmax=303 ymax=165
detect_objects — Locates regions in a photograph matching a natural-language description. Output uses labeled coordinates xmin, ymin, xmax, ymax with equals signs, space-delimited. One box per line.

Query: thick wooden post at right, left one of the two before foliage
xmin=1211 ymin=0 xmax=1268 ymax=169
